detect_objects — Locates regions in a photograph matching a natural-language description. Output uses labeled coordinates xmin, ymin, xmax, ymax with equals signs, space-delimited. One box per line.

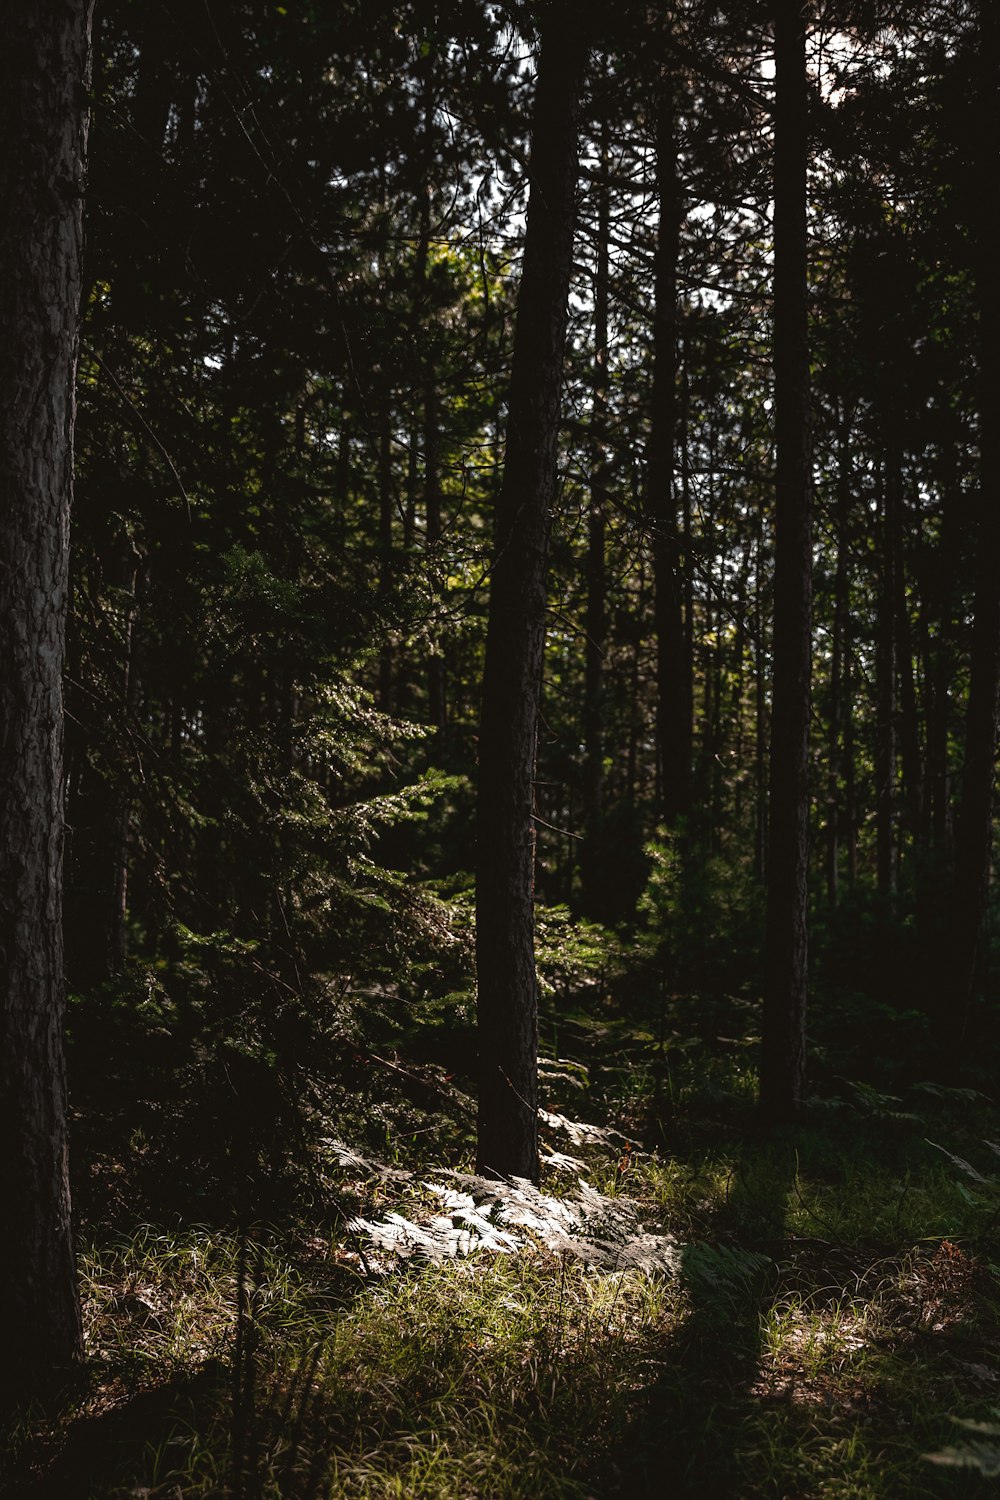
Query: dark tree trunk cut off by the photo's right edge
xmin=949 ymin=0 xmax=1000 ymax=1052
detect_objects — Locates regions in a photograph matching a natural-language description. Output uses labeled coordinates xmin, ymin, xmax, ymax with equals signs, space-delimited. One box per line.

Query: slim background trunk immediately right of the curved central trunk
xmin=580 ymin=120 xmax=610 ymax=917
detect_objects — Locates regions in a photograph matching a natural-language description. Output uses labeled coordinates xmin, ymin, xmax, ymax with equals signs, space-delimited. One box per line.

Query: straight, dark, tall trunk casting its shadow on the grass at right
xmin=760 ymin=0 xmax=813 ymax=1121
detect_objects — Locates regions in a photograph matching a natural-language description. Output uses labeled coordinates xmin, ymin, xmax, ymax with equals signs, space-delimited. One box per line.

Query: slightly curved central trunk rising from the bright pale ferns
xmin=477 ymin=6 xmax=586 ymax=1179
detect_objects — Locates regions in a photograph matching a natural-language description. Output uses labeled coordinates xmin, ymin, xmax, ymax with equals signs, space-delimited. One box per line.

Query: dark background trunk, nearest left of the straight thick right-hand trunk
xmin=646 ymin=69 xmax=691 ymax=827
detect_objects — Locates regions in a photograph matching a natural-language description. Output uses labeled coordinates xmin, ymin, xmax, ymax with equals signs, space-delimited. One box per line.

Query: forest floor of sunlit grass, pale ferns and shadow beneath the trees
xmin=0 ymin=990 xmax=1000 ymax=1500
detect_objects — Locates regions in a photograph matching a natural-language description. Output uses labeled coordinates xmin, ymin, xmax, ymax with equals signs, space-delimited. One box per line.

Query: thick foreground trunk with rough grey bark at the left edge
xmin=0 ymin=0 xmax=90 ymax=1389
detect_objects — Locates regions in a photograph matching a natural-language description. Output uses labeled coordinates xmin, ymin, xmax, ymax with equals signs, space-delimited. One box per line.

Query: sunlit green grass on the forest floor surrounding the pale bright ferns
xmin=15 ymin=1094 xmax=997 ymax=1500
